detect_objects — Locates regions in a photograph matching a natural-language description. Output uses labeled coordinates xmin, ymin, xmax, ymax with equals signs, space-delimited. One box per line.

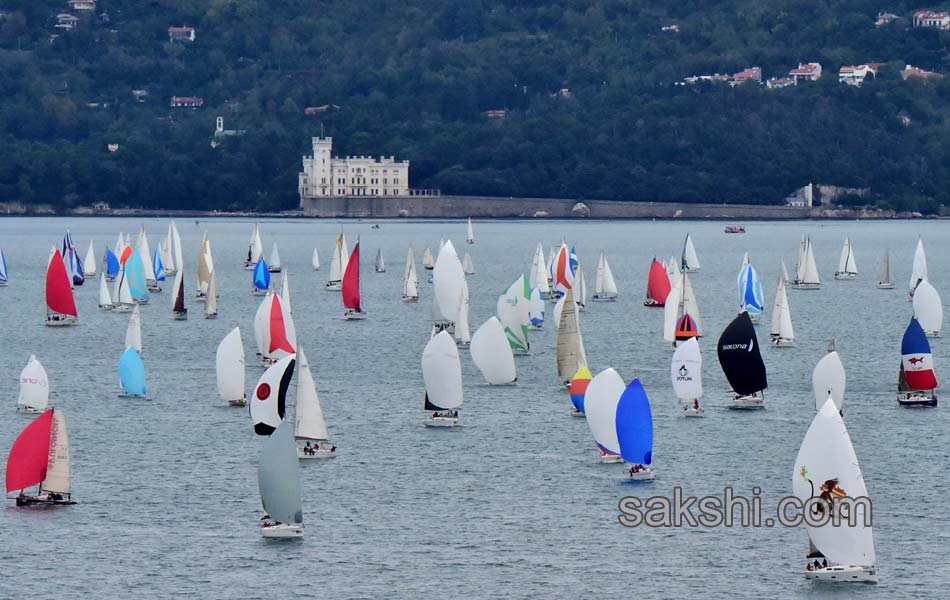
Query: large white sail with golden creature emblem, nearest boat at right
xmin=792 ymin=398 xmax=877 ymax=567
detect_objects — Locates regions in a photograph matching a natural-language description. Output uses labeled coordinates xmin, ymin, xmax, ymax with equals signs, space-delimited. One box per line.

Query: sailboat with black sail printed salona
xmin=717 ymin=312 xmax=768 ymax=409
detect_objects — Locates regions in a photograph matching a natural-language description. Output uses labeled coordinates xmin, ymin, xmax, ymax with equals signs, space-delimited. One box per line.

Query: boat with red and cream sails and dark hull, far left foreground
xmin=6 ymin=408 xmax=76 ymax=506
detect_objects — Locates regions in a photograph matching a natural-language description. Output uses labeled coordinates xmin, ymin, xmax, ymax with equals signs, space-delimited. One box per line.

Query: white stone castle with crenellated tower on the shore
xmin=297 ymin=137 xmax=409 ymax=202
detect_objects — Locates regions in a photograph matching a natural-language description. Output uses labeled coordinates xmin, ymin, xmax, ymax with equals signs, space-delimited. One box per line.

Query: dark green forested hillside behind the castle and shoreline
xmin=0 ymin=0 xmax=950 ymax=212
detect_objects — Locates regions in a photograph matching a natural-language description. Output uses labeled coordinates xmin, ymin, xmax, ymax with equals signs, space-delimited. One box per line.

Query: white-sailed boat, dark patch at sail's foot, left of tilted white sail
xmin=422 ymin=331 xmax=463 ymax=427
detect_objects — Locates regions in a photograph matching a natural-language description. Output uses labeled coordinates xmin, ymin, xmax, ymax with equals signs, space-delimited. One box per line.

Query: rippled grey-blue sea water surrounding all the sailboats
xmin=0 ymin=219 xmax=950 ymax=599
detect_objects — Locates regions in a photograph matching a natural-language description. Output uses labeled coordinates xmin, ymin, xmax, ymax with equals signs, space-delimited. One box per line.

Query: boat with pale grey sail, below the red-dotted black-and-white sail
xmin=257 ymin=423 xmax=303 ymax=539
